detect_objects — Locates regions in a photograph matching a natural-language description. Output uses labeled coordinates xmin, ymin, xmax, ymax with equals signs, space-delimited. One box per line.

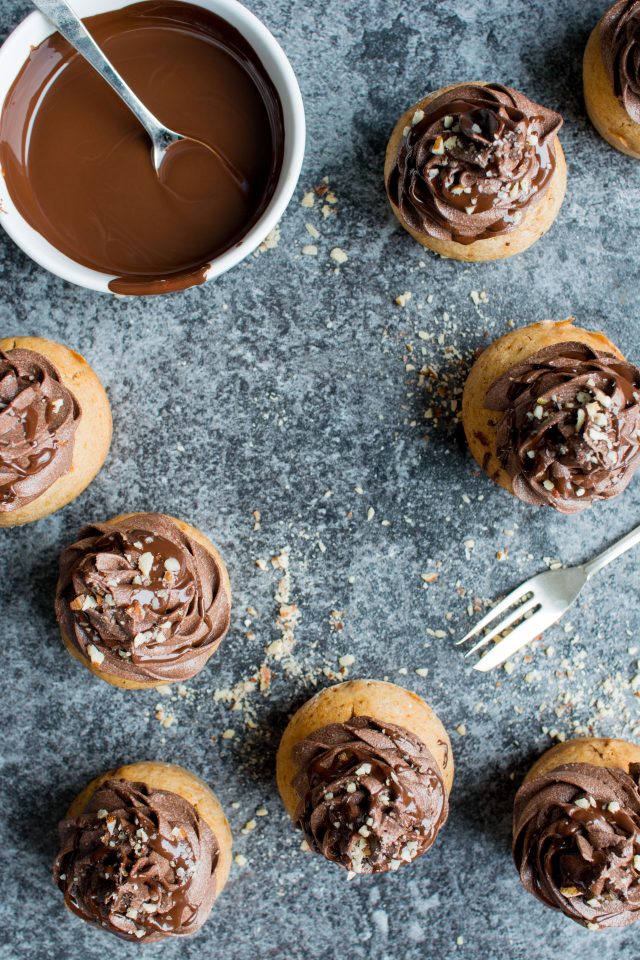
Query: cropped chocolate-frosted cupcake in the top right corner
xmin=584 ymin=0 xmax=640 ymax=159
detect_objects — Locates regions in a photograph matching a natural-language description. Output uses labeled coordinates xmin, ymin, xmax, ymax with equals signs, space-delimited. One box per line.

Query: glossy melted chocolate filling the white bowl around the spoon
xmin=0 ymin=0 xmax=284 ymax=294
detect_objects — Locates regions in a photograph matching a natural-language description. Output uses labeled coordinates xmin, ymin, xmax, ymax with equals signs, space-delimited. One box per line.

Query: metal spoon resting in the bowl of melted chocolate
xmin=33 ymin=0 xmax=247 ymax=185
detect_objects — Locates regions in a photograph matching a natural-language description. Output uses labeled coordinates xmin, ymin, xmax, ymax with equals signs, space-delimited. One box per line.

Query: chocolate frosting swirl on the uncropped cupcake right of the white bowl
xmin=387 ymin=84 xmax=562 ymax=244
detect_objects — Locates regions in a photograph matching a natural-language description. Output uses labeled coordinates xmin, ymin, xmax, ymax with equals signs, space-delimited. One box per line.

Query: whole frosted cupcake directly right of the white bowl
xmin=385 ymin=83 xmax=567 ymax=261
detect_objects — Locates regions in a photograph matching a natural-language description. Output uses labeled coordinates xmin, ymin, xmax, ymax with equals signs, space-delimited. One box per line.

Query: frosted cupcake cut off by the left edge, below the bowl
xmin=0 ymin=337 xmax=111 ymax=527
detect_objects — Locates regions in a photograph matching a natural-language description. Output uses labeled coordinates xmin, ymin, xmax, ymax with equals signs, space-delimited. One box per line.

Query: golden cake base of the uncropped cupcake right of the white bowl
xmin=384 ymin=81 xmax=567 ymax=263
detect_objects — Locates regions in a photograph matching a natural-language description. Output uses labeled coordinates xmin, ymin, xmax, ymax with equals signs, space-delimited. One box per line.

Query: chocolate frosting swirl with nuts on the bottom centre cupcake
xmin=293 ymin=717 xmax=449 ymax=873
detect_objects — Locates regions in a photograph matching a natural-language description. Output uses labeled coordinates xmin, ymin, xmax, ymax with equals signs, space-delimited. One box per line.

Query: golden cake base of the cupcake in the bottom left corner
xmin=67 ymin=760 xmax=232 ymax=898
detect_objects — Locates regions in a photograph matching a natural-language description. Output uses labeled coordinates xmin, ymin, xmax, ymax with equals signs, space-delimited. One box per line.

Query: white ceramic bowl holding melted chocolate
xmin=0 ymin=0 xmax=305 ymax=293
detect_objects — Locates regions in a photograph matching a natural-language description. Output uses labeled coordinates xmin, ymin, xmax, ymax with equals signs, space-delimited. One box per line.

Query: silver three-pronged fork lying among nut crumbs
xmin=458 ymin=527 xmax=640 ymax=673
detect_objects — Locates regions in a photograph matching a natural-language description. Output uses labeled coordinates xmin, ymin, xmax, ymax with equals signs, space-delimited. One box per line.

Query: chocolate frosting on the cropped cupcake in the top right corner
xmin=600 ymin=0 xmax=640 ymax=123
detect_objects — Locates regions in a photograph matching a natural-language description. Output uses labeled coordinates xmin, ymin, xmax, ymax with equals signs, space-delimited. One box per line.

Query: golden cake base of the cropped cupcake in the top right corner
xmin=583 ymin=24 xmax=640 ymax=160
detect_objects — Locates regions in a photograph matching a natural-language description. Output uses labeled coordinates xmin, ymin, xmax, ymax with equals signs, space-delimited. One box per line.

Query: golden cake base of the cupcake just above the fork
xmin=462 ymin=319 xmax=623 ymax=493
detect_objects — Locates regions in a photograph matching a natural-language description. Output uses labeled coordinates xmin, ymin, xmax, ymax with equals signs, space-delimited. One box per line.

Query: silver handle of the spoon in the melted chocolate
xmin=33 ymin=0 xmax=165 ymax=144
